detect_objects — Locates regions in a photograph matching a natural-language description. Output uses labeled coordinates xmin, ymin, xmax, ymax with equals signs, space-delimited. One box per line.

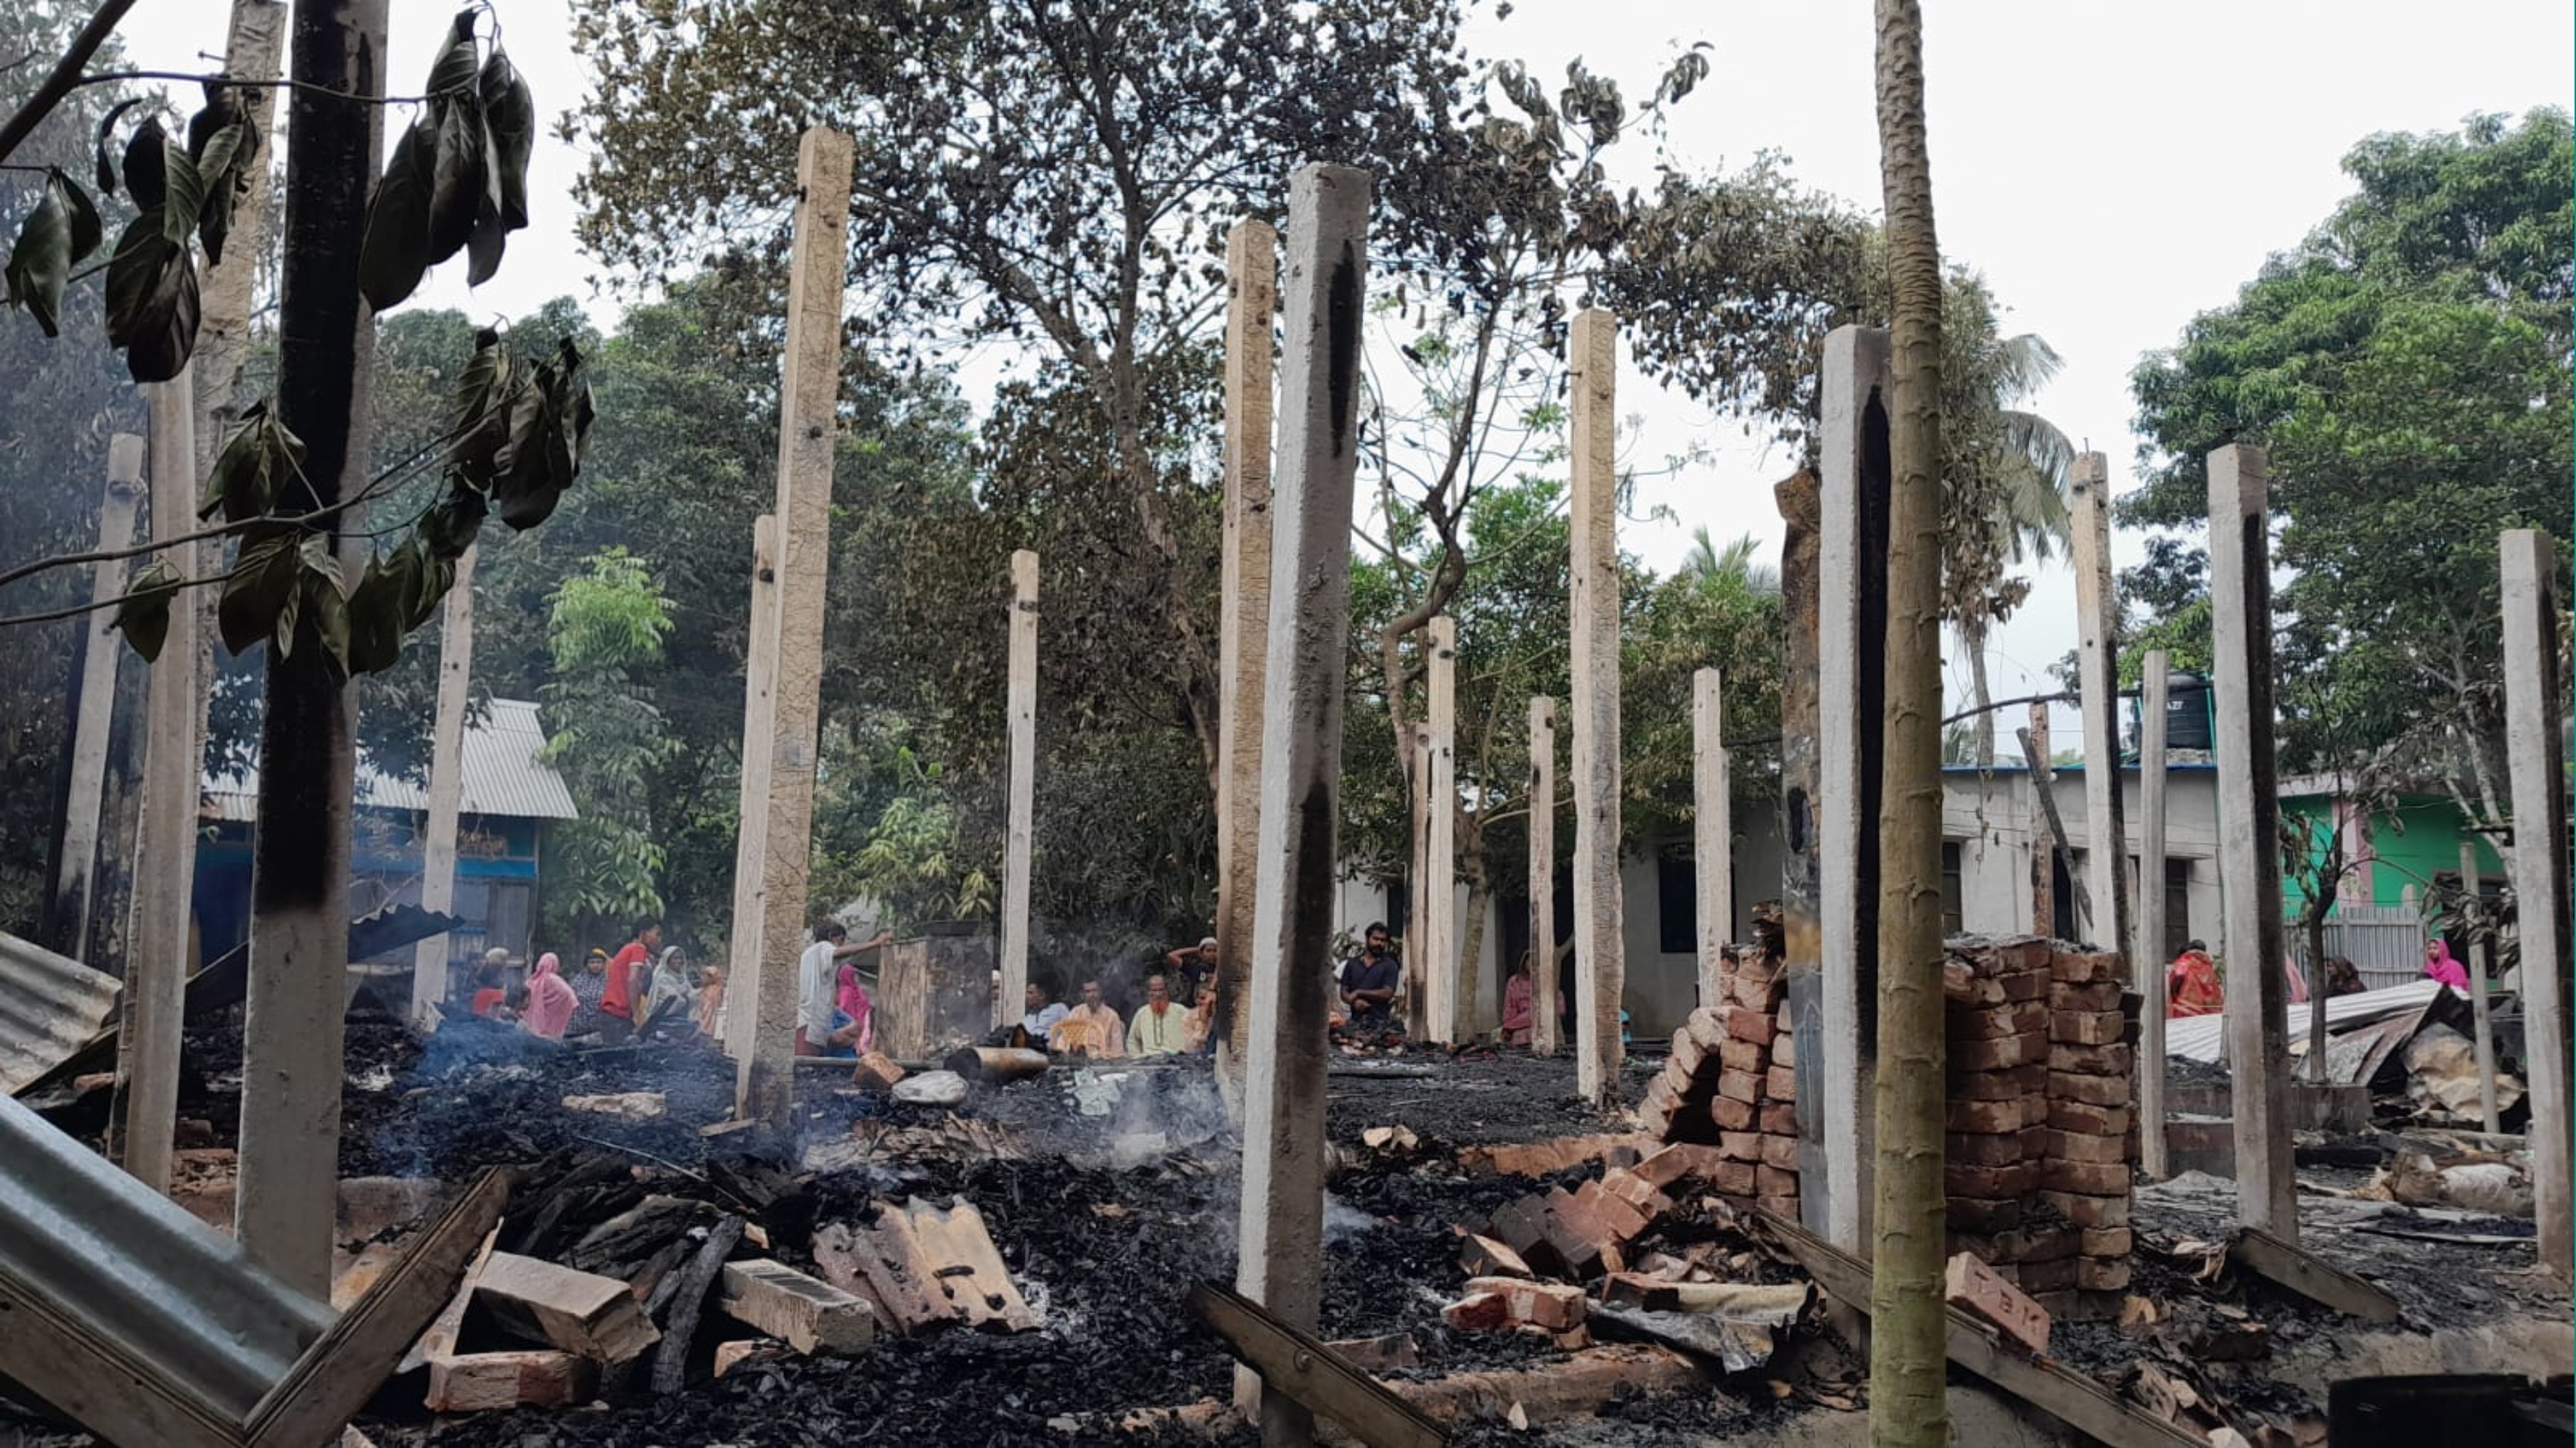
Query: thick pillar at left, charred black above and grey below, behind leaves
xmin=235 ymin=0 xmax=386 ymax=1296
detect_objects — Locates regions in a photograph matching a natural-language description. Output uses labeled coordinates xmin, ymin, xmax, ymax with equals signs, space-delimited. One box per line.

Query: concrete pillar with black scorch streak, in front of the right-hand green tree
xmin=2210 ymin=443 xmax=2298 ymax=1242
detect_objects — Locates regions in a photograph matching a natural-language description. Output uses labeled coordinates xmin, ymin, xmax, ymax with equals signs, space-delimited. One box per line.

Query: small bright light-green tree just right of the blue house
xmin=538 ymin=549 xmax=677 ymax=940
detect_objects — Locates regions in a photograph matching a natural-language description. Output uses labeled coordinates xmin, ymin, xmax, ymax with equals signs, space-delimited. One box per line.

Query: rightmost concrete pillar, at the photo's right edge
xmin=2496 ymin=528 xmax=2576 ymax=1278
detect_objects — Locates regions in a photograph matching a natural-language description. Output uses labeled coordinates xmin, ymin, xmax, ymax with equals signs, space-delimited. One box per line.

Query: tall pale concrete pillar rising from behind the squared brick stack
xmin=2068 ymin=453 xmax=2154 ymax=958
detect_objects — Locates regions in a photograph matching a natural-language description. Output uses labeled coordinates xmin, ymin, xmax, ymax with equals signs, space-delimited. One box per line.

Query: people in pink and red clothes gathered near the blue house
xmin=466 ymin=920 xmax=724 ymax=1046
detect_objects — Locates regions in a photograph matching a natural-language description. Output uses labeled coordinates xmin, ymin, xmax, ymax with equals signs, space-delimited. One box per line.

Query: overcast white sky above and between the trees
xmin=121 ymin=0 xmax=2576 ymax=696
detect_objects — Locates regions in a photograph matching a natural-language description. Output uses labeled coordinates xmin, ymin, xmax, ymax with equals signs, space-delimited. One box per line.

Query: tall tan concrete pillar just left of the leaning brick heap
xmin=1569 ymin=307 xmax=1628 ymax=1103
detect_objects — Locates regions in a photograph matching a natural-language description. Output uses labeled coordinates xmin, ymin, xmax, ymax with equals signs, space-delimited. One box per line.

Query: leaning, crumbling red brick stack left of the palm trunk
xmin=1638 ymin=945 xmax=1798 ymax=1221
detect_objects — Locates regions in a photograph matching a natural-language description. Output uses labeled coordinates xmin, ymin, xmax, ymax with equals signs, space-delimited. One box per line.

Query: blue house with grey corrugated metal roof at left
xmin=196 ymin=699 xmax=580 ymax=961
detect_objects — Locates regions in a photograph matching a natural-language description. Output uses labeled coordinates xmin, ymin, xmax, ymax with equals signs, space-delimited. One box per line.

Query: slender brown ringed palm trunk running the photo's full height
xmin=1870 ymin=0 xmax=1950 ymax=1448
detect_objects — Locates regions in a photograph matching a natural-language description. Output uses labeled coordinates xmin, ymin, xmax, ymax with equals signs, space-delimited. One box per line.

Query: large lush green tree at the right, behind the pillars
xmin=2123 ymin=111 xmax=2576 ymax=855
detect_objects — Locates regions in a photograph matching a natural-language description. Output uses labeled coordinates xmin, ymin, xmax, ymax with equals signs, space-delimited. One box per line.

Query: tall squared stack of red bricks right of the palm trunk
xmin=1942 ymin=938 xmax=2133 ymax=1316
